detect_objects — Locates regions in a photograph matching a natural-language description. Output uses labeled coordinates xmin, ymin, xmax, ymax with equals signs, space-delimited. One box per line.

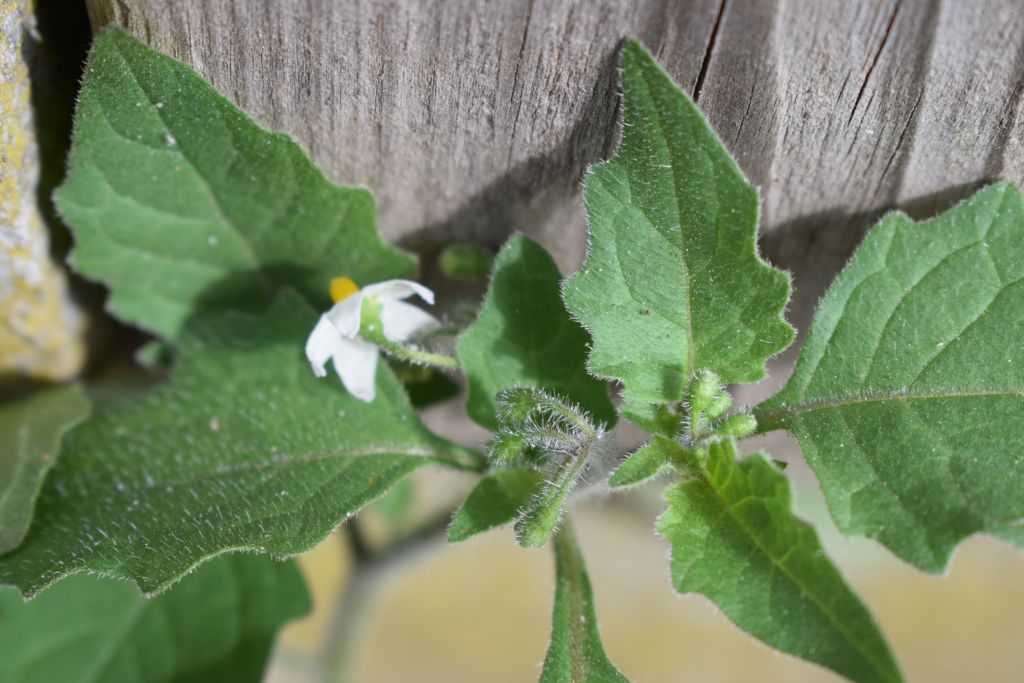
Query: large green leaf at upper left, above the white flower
xmin=56 ymin=30 xmax=413 ymax=338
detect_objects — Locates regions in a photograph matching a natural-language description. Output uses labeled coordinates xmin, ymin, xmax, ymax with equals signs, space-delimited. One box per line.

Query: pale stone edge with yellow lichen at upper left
xmin=0 ymin=0 xmax=83 ymax=380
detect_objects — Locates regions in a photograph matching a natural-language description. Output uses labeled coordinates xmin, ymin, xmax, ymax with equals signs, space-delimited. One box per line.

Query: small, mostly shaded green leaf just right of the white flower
xmin=459 ymin=234 xmax=615 ymax=429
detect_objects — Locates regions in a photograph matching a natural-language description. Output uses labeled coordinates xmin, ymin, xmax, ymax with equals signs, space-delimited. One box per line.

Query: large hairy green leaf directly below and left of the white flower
xmin=0 ymin=292 xmax=476 ymax=595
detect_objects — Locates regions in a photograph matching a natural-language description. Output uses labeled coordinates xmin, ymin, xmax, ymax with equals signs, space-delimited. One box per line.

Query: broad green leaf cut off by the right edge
xmin=756 ymin=182 xmax=1024 ymax=572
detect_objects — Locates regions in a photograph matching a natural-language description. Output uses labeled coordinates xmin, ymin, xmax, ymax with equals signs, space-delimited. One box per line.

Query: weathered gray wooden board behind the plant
xmin=88 ymin=0 xmax=1024 ymax=323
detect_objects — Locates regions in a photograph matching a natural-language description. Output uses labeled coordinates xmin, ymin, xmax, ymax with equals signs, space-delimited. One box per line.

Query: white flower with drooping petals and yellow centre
xmin=306 ymin=278 xmax=439 ymax=402
